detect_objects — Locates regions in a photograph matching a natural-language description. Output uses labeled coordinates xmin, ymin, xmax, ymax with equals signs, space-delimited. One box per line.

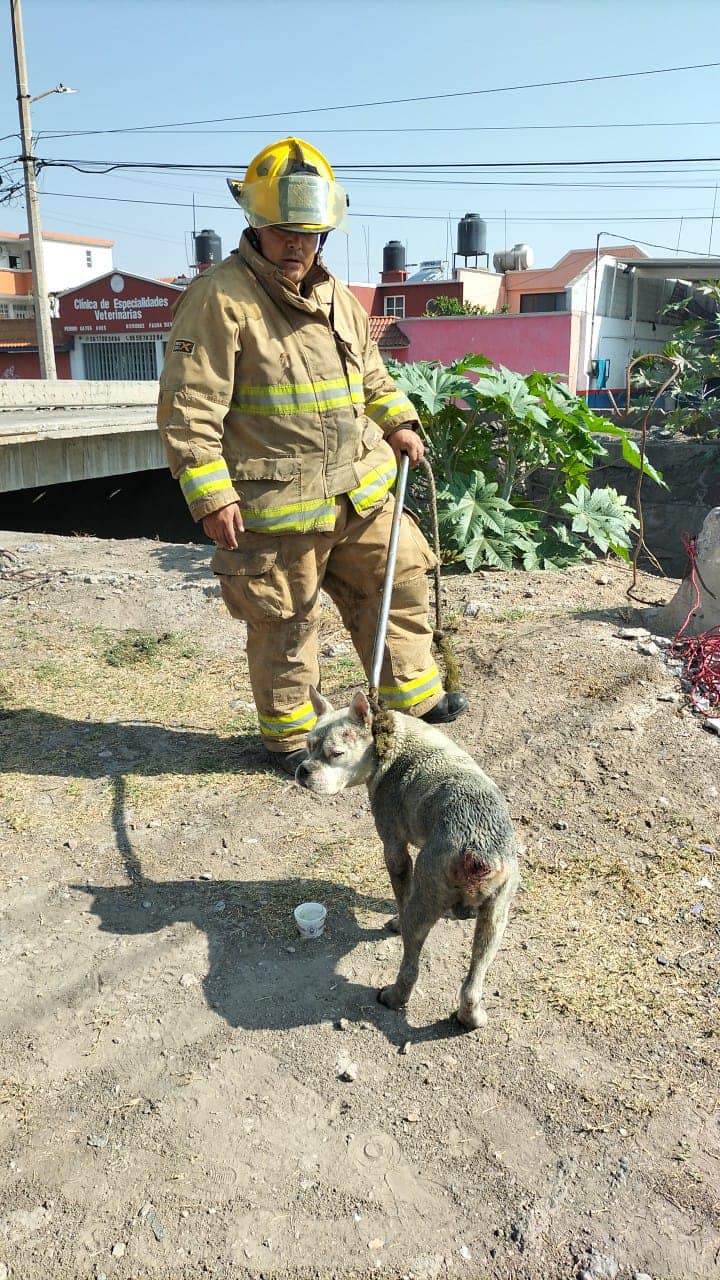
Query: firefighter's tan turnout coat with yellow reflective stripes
xmin=158 ymin=232 xmax=418 ymax=534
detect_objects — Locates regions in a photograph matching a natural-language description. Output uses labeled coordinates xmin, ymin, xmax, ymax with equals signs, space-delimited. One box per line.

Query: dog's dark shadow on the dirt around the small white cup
xmin=70 ymin=874 xmax=462 ymax=1047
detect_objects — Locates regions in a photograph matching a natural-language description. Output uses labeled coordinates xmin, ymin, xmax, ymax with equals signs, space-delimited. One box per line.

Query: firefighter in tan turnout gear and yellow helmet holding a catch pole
xmin=158 ymin=138 xmax=468 ymax=774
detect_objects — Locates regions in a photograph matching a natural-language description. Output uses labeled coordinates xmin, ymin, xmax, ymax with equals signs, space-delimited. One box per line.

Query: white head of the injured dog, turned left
xmin=295 ymin=689 xmax=377 ymax=796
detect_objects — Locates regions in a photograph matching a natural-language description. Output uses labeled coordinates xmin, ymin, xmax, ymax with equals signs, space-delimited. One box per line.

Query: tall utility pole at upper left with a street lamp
xmin=10 ymin=0 xmax=58 ymax=379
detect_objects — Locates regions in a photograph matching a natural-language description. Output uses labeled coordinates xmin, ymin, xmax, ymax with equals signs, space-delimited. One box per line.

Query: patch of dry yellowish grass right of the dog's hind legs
xmin=511 ymin=844 xmax=719 ymax=1037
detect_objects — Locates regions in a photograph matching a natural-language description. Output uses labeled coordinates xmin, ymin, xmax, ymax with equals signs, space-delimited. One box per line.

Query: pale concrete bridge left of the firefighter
xmin=0 ymin=378 xmax=168 ymax=493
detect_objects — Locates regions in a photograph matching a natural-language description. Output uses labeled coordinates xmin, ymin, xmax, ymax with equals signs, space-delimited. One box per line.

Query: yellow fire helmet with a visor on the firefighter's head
xmin=228 ymin=138 xmax=350 ymax=233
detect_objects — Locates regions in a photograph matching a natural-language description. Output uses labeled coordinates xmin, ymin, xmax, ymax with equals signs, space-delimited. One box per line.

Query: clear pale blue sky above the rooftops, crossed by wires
xmin=0 ymin=0 xmax=720 ymax=282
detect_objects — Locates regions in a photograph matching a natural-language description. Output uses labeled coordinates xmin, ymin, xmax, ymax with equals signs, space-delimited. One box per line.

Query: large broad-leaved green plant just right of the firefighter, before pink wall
xmin=388 ymin=355 xmax=664 ymax=570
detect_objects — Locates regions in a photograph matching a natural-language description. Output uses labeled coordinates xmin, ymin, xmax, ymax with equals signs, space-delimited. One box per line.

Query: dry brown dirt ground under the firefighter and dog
xmin=0 ymin=532 xmax=720 ymax=1280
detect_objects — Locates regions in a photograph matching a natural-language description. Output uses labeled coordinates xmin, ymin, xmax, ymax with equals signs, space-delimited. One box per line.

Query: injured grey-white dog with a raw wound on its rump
xmin=295 ymin=689 xmax=520 ymax=1028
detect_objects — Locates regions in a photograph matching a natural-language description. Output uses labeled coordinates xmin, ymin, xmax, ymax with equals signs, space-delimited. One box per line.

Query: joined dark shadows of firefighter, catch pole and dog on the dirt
xmin=0 ymin=709 xmax=462 ymax=1046
